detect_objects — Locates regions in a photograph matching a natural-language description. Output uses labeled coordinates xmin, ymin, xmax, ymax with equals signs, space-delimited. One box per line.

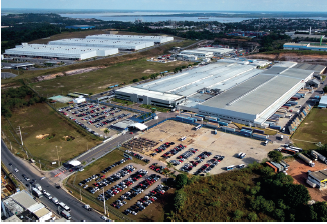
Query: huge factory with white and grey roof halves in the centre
xmin=116 ymin=59 xmax=325 ymax=127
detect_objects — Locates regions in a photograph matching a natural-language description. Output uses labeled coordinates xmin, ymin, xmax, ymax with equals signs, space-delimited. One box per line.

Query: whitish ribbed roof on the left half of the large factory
xmin=137 ymin=60 xmax=262 ymax=96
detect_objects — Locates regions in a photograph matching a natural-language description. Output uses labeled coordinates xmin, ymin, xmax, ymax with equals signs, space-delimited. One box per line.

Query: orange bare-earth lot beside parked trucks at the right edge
xmin=286 ymin=159 xmax=327 ymax=201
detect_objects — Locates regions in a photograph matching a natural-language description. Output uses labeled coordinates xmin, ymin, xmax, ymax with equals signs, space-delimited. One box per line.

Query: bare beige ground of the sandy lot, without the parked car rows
xmin=134 ymin=121 xmax=279 ymax=174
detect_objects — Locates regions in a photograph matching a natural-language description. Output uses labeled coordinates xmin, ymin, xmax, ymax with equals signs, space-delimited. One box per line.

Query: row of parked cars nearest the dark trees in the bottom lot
xmin=123 ymin=185 xmax=169 ymax=215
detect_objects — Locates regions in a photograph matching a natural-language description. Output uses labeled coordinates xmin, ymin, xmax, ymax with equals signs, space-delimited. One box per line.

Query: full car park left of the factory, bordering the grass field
xmin=58 ymin=103 xmax=136 ymax=138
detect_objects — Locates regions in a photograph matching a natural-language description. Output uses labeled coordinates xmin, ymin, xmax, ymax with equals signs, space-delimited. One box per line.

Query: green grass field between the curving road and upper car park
xmin=1 ymin=104 xmax=100 ymax=169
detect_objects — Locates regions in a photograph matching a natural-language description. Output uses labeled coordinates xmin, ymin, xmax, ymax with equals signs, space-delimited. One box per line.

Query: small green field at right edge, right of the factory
xmin=292 ymin=108 xmax=327 ymax=149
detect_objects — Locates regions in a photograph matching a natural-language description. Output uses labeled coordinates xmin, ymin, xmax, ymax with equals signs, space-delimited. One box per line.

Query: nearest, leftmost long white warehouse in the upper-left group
xmin=4 ymin=43 xmax=118 ymax=60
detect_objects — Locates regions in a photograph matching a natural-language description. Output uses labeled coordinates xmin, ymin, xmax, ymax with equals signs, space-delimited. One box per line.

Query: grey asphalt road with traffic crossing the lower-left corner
xmin=1 ymin=140 xmax=103 ymax=222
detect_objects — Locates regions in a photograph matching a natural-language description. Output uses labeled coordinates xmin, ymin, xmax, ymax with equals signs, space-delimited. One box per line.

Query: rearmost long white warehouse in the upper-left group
xmin=86 ymin=34 xmax=174 ymax=44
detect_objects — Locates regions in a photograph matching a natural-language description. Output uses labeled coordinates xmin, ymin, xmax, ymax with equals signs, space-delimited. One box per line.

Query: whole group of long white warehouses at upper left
xmin=4 ymin=34 xmax=174 ymax=60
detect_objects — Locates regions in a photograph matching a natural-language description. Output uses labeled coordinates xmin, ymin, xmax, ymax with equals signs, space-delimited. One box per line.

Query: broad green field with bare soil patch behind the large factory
xmin=31 ymin=59 xmax=188 ymax=97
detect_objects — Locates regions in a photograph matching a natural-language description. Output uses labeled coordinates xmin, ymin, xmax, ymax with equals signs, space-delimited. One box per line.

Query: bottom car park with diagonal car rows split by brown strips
xmin=78 ymin=159 xmax=169 ymax=217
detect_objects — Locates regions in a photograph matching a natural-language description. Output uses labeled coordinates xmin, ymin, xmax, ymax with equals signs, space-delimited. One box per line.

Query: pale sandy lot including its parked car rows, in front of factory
xmin=134 ymin=121 xmax=279 ymax=174
